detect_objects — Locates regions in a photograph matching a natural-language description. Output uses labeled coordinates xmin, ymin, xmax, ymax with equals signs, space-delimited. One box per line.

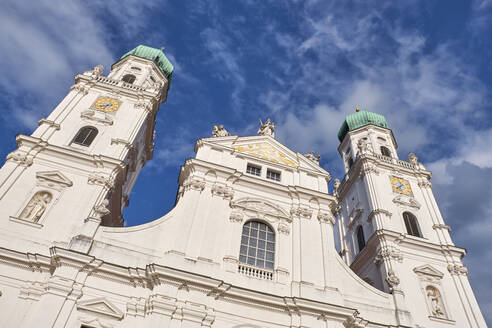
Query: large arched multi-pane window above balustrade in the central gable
xmin=239 ymin=221 xmax=275 ymax=270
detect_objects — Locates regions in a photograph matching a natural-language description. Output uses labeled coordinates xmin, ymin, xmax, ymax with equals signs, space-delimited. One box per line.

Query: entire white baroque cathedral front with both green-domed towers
xmin=0 ymin=46 xmax=486 ymax=328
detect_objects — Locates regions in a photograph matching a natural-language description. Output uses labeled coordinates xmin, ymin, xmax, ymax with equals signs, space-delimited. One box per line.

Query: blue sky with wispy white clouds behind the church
xmin=0 ymin=0 xmax=492 ymax=325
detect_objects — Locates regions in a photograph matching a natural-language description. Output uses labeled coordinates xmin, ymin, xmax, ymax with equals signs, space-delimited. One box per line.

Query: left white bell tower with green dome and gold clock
xmin=0 ymin=45 xmax=173 ymax=248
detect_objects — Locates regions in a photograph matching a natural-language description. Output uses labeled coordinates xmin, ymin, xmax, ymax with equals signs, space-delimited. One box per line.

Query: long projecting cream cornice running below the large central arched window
xmin=0 ymin=247 xmax=370 ymax=320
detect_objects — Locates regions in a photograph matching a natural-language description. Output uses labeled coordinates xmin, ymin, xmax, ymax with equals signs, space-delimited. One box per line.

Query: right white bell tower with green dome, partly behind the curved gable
xmin=334 ymin=111 xmax=485 ymax=327
